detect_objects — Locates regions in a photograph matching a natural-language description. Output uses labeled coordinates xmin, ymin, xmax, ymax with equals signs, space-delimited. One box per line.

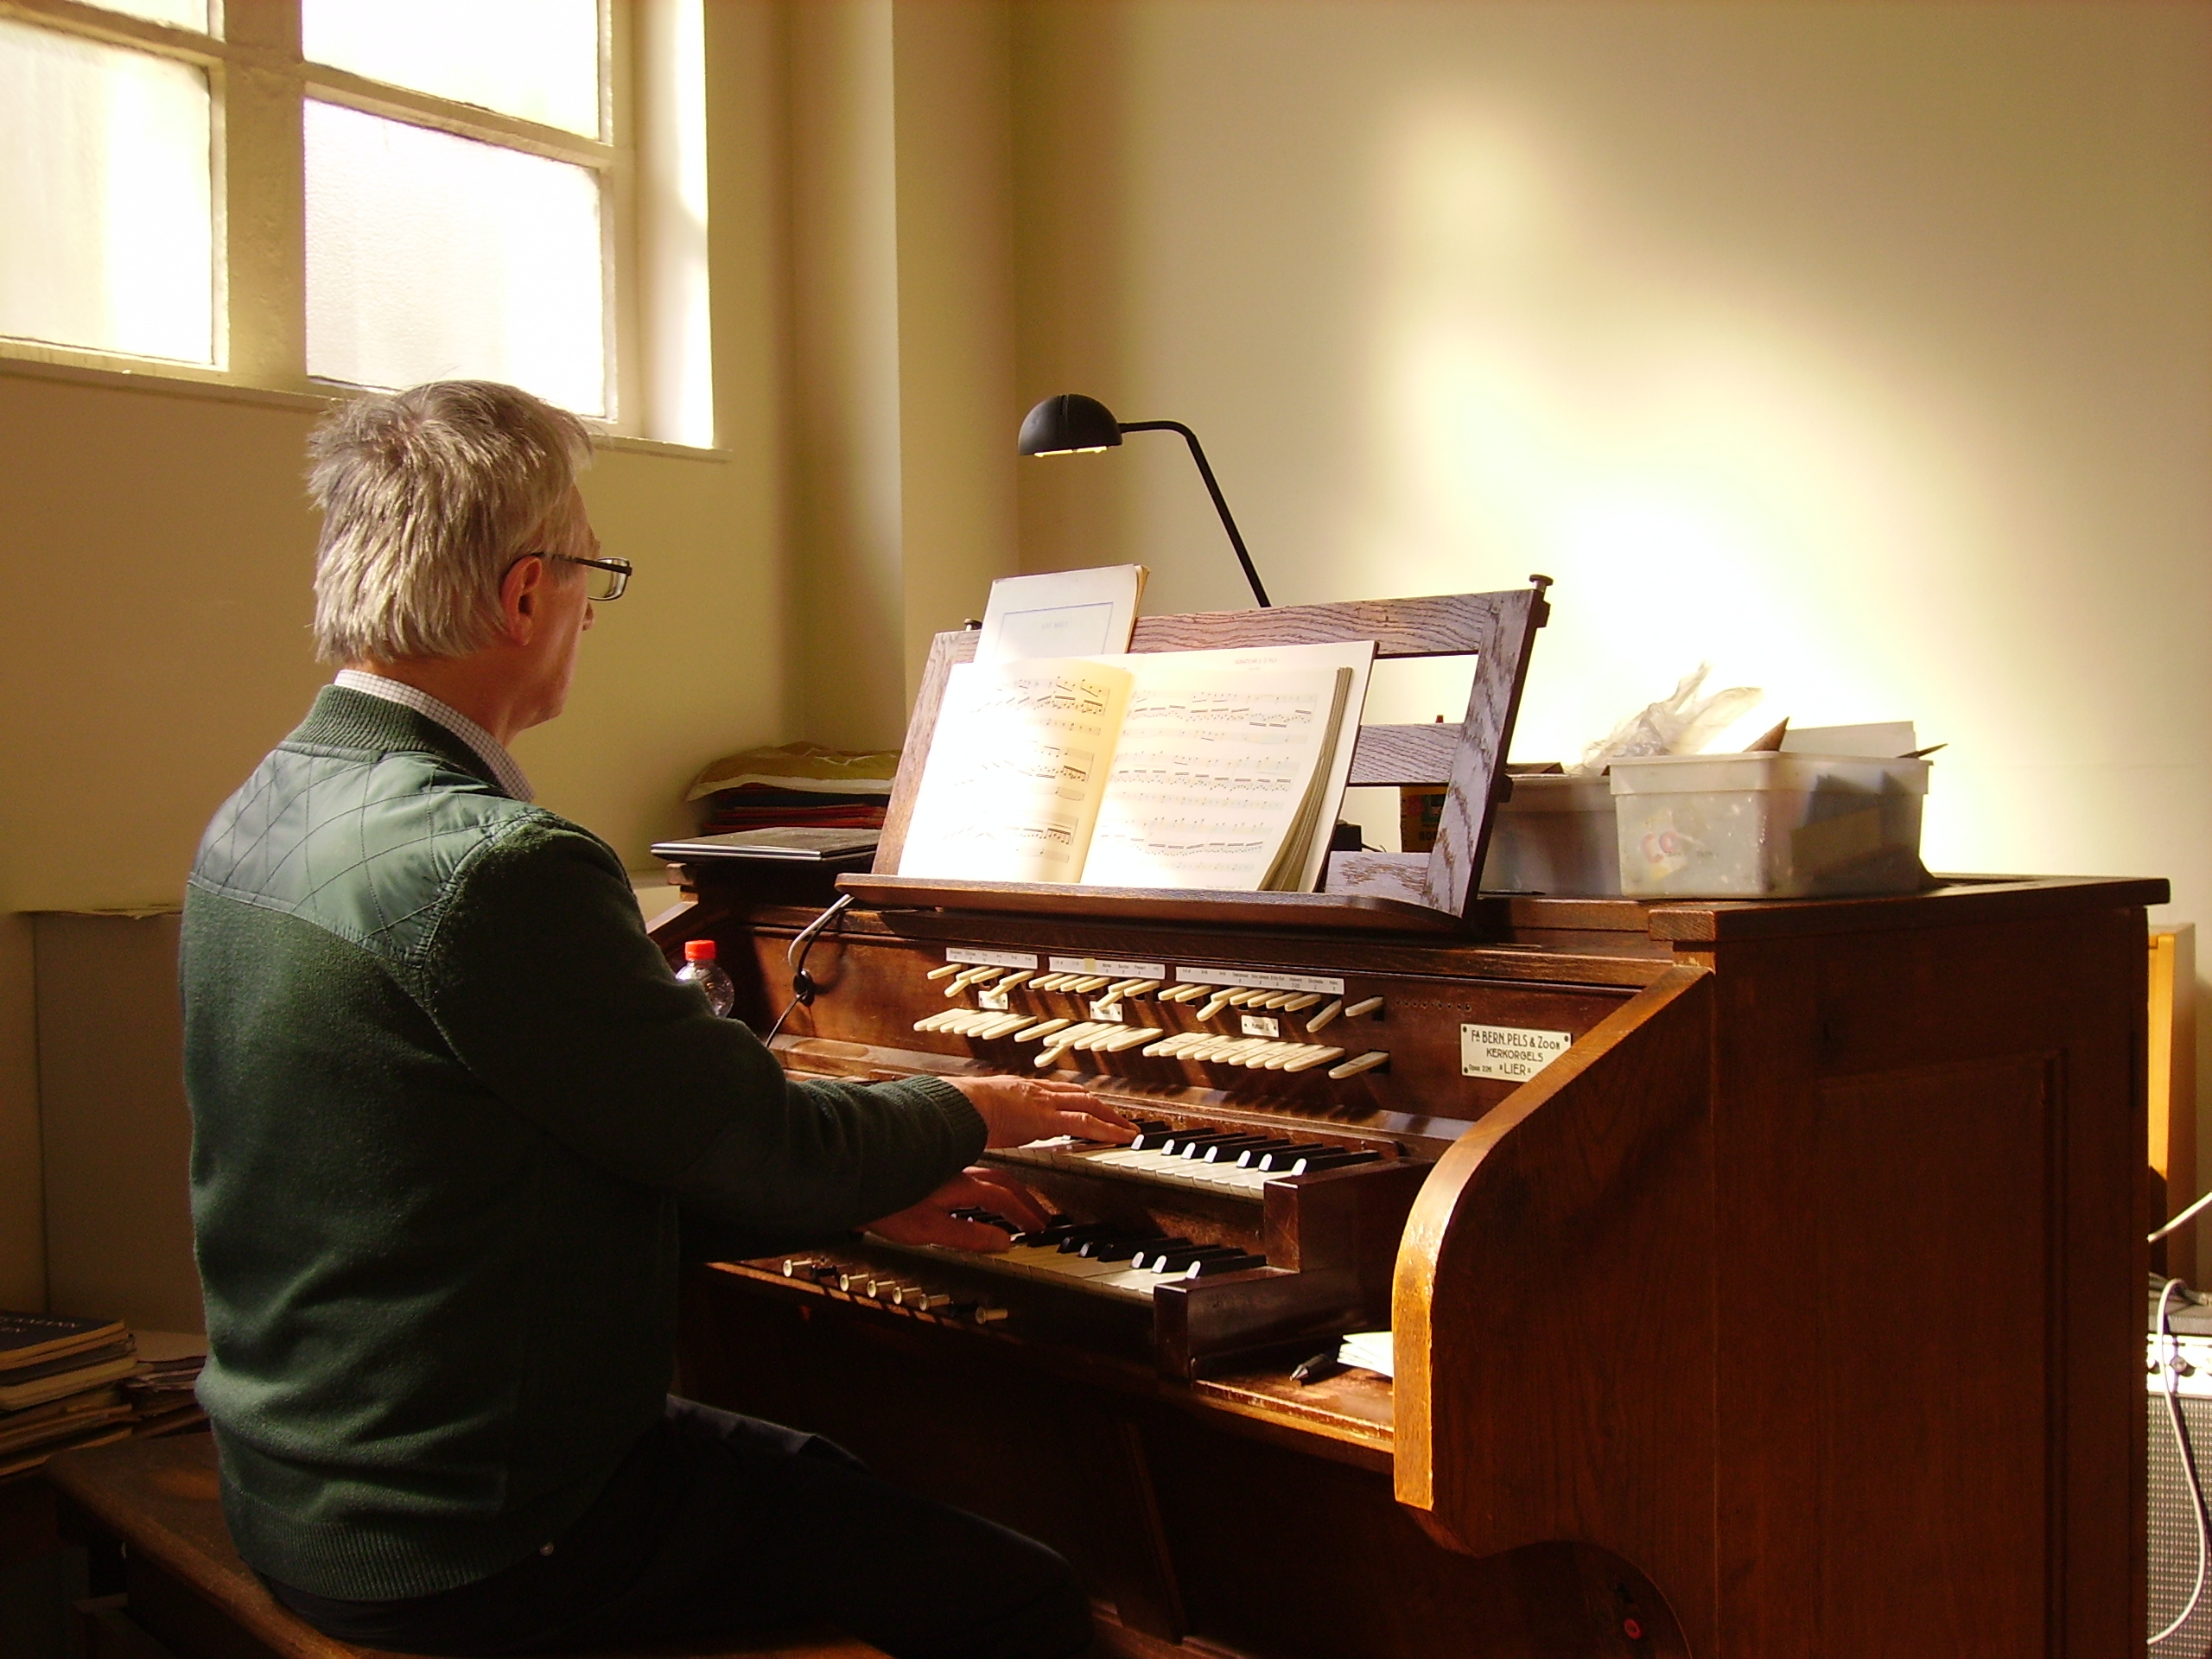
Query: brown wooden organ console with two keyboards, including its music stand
xmin=655 ymin=580 xmax=2165 ymax=1659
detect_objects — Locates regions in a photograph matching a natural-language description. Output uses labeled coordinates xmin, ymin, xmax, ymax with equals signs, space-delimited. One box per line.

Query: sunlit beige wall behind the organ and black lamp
xmin=1015 ymin=0 xmax=2212 ymax=938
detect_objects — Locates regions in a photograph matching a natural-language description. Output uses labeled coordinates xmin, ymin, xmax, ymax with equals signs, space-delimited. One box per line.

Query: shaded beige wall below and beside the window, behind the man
xmin=0 ymin=0 xmax=787 ymax=1305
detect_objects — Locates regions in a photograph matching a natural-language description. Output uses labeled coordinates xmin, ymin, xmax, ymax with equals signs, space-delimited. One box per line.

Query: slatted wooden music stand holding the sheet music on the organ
xmin=838 ymin=575 xmax=1551 ymax=933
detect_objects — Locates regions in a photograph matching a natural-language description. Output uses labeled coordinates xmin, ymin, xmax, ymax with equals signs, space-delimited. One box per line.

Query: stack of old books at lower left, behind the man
xmin=0 ymin=1314 xmax=208 ymax=1480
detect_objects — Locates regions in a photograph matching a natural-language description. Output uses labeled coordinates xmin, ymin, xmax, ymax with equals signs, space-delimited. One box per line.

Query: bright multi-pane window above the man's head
xmin=0 ymin=0 xmax=710 ymax=440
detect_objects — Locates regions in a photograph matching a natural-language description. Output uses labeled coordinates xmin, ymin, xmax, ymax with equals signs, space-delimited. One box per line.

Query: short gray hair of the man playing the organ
xmin=308 ymin=380 xmax=591 ymax=664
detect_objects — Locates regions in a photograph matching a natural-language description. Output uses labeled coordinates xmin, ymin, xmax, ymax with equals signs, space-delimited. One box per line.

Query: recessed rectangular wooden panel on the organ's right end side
xmin=1796 ymin=1055 xmax=2063 ymax=1659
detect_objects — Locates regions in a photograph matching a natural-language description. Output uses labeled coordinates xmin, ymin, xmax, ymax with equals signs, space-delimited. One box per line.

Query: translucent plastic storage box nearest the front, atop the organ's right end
xmin=1610 ymin=752 xmax=1929 ymax=898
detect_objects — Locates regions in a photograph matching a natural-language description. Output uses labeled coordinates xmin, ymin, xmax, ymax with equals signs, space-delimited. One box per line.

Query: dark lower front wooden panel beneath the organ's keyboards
xmin=679 ymin=1274 xmax=1681 ymax=1659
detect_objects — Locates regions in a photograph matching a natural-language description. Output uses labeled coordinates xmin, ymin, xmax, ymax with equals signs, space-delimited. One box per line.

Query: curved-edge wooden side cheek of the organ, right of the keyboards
xmin=1394 ymin=969 xmax=1717 ymax=1652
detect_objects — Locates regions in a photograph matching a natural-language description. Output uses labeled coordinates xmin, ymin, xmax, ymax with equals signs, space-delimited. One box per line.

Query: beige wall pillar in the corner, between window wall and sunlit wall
xmin=790 ymin=0 xmax=1020 ymax=747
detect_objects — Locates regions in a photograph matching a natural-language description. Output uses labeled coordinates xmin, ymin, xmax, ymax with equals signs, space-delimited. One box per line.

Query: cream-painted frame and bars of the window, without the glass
xmin=0 ymin=0 xmax=699 ymax=454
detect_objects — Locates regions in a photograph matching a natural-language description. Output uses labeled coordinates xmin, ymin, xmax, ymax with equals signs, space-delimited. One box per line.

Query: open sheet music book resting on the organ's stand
xmin=898 ymin=639 xmax=1374 ymax=892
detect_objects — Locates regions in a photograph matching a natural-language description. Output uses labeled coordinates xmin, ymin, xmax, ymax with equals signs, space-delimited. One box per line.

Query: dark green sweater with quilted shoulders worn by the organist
xmin=183 ymin=688 xmax=984 ymax=1599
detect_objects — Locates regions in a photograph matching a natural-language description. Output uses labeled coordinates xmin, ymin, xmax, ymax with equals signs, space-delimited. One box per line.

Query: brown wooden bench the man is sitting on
xmin=47 ymin=1433 xmax=885 ymax=1659
